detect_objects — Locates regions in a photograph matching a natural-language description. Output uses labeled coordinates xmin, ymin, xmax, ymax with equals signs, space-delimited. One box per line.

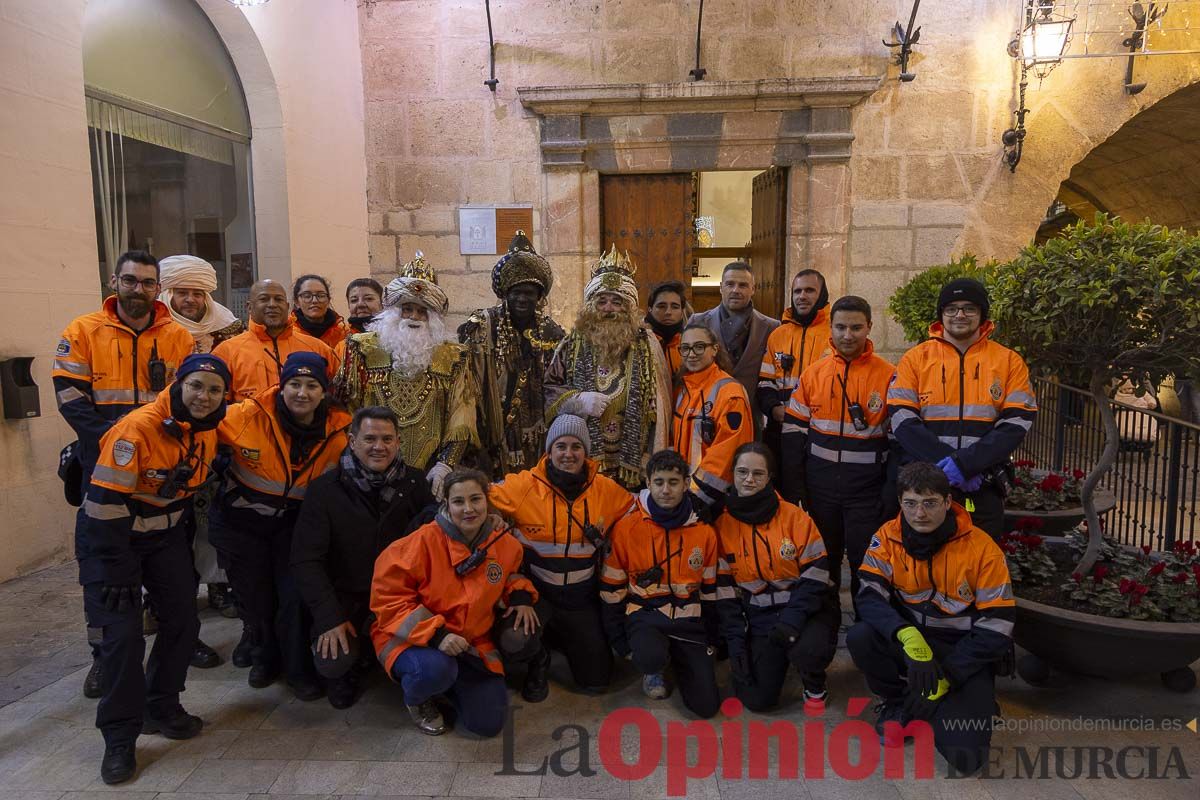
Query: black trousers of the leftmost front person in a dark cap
xmin=83 ymin=527 xmax=200 ymax=745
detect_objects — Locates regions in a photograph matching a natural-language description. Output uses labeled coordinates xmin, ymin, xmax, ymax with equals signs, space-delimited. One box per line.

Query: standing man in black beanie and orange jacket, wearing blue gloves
xmin=888 ymin=278 xmax=1038 ymax=537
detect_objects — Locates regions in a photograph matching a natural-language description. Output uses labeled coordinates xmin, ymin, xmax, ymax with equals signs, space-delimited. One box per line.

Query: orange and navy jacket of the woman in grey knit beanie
xmin=488 ymin=457 xmax=634 ymax=608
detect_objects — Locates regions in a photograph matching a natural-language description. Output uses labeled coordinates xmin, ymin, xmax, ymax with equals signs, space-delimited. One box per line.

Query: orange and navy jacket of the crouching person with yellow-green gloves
xmin=857 ymin=504 xmax=1016 ymax=685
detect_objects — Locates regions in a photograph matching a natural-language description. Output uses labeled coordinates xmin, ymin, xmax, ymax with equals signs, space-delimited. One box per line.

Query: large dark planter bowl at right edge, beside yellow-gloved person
xmin=1014 ymin=597 xmax=1200 ymax=691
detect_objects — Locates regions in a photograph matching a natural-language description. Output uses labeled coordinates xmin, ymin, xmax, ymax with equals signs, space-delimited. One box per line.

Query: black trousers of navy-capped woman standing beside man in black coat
xmin=214 ymin=517 xmax=317 ymax=682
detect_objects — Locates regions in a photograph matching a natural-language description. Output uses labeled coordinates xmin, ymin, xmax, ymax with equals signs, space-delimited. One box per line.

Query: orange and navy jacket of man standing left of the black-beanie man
xmin=782 ymin=339 xmax=895 ymax=500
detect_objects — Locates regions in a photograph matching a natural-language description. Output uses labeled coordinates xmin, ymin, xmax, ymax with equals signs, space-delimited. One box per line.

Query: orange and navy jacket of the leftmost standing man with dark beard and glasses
xmin=50 ymin=296 xmax=194 ymax=474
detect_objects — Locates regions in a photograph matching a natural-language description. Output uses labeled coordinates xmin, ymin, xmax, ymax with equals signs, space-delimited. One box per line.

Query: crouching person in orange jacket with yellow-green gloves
xmin=846 ymin=462 xmax=1016 ymax=774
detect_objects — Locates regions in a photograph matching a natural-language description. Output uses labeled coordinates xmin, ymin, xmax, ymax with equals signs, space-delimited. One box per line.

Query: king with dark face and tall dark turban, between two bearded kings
xmin=458 ymin=230 xmax=564 ymax=480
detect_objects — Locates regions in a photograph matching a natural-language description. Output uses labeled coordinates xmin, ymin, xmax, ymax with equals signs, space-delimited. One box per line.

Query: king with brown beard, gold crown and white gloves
xmin=546 ymin=245 xmax=671 ymax=491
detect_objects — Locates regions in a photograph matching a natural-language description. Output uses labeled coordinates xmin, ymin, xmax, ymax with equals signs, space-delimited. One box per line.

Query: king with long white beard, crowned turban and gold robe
xmin=332 ymin=251 xmax=479 ymax=497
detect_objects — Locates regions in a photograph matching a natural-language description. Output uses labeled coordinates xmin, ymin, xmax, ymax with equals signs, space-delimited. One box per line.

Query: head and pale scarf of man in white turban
xmin=158 ymin=255 xmax=246 ymax=353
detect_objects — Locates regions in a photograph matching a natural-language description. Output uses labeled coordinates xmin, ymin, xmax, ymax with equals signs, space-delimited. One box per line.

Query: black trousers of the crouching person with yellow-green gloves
xmin=846 ymin=622 xmax=996 ymax=774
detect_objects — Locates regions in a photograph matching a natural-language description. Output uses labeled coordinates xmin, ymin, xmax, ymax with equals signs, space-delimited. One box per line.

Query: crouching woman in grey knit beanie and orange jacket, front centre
xmin=488 ymin=414 xmax=634 ymax=703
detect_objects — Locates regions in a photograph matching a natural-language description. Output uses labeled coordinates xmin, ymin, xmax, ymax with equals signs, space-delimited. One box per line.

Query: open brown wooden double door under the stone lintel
xmin=600 ymin=167 xmax=787 ymax=318
